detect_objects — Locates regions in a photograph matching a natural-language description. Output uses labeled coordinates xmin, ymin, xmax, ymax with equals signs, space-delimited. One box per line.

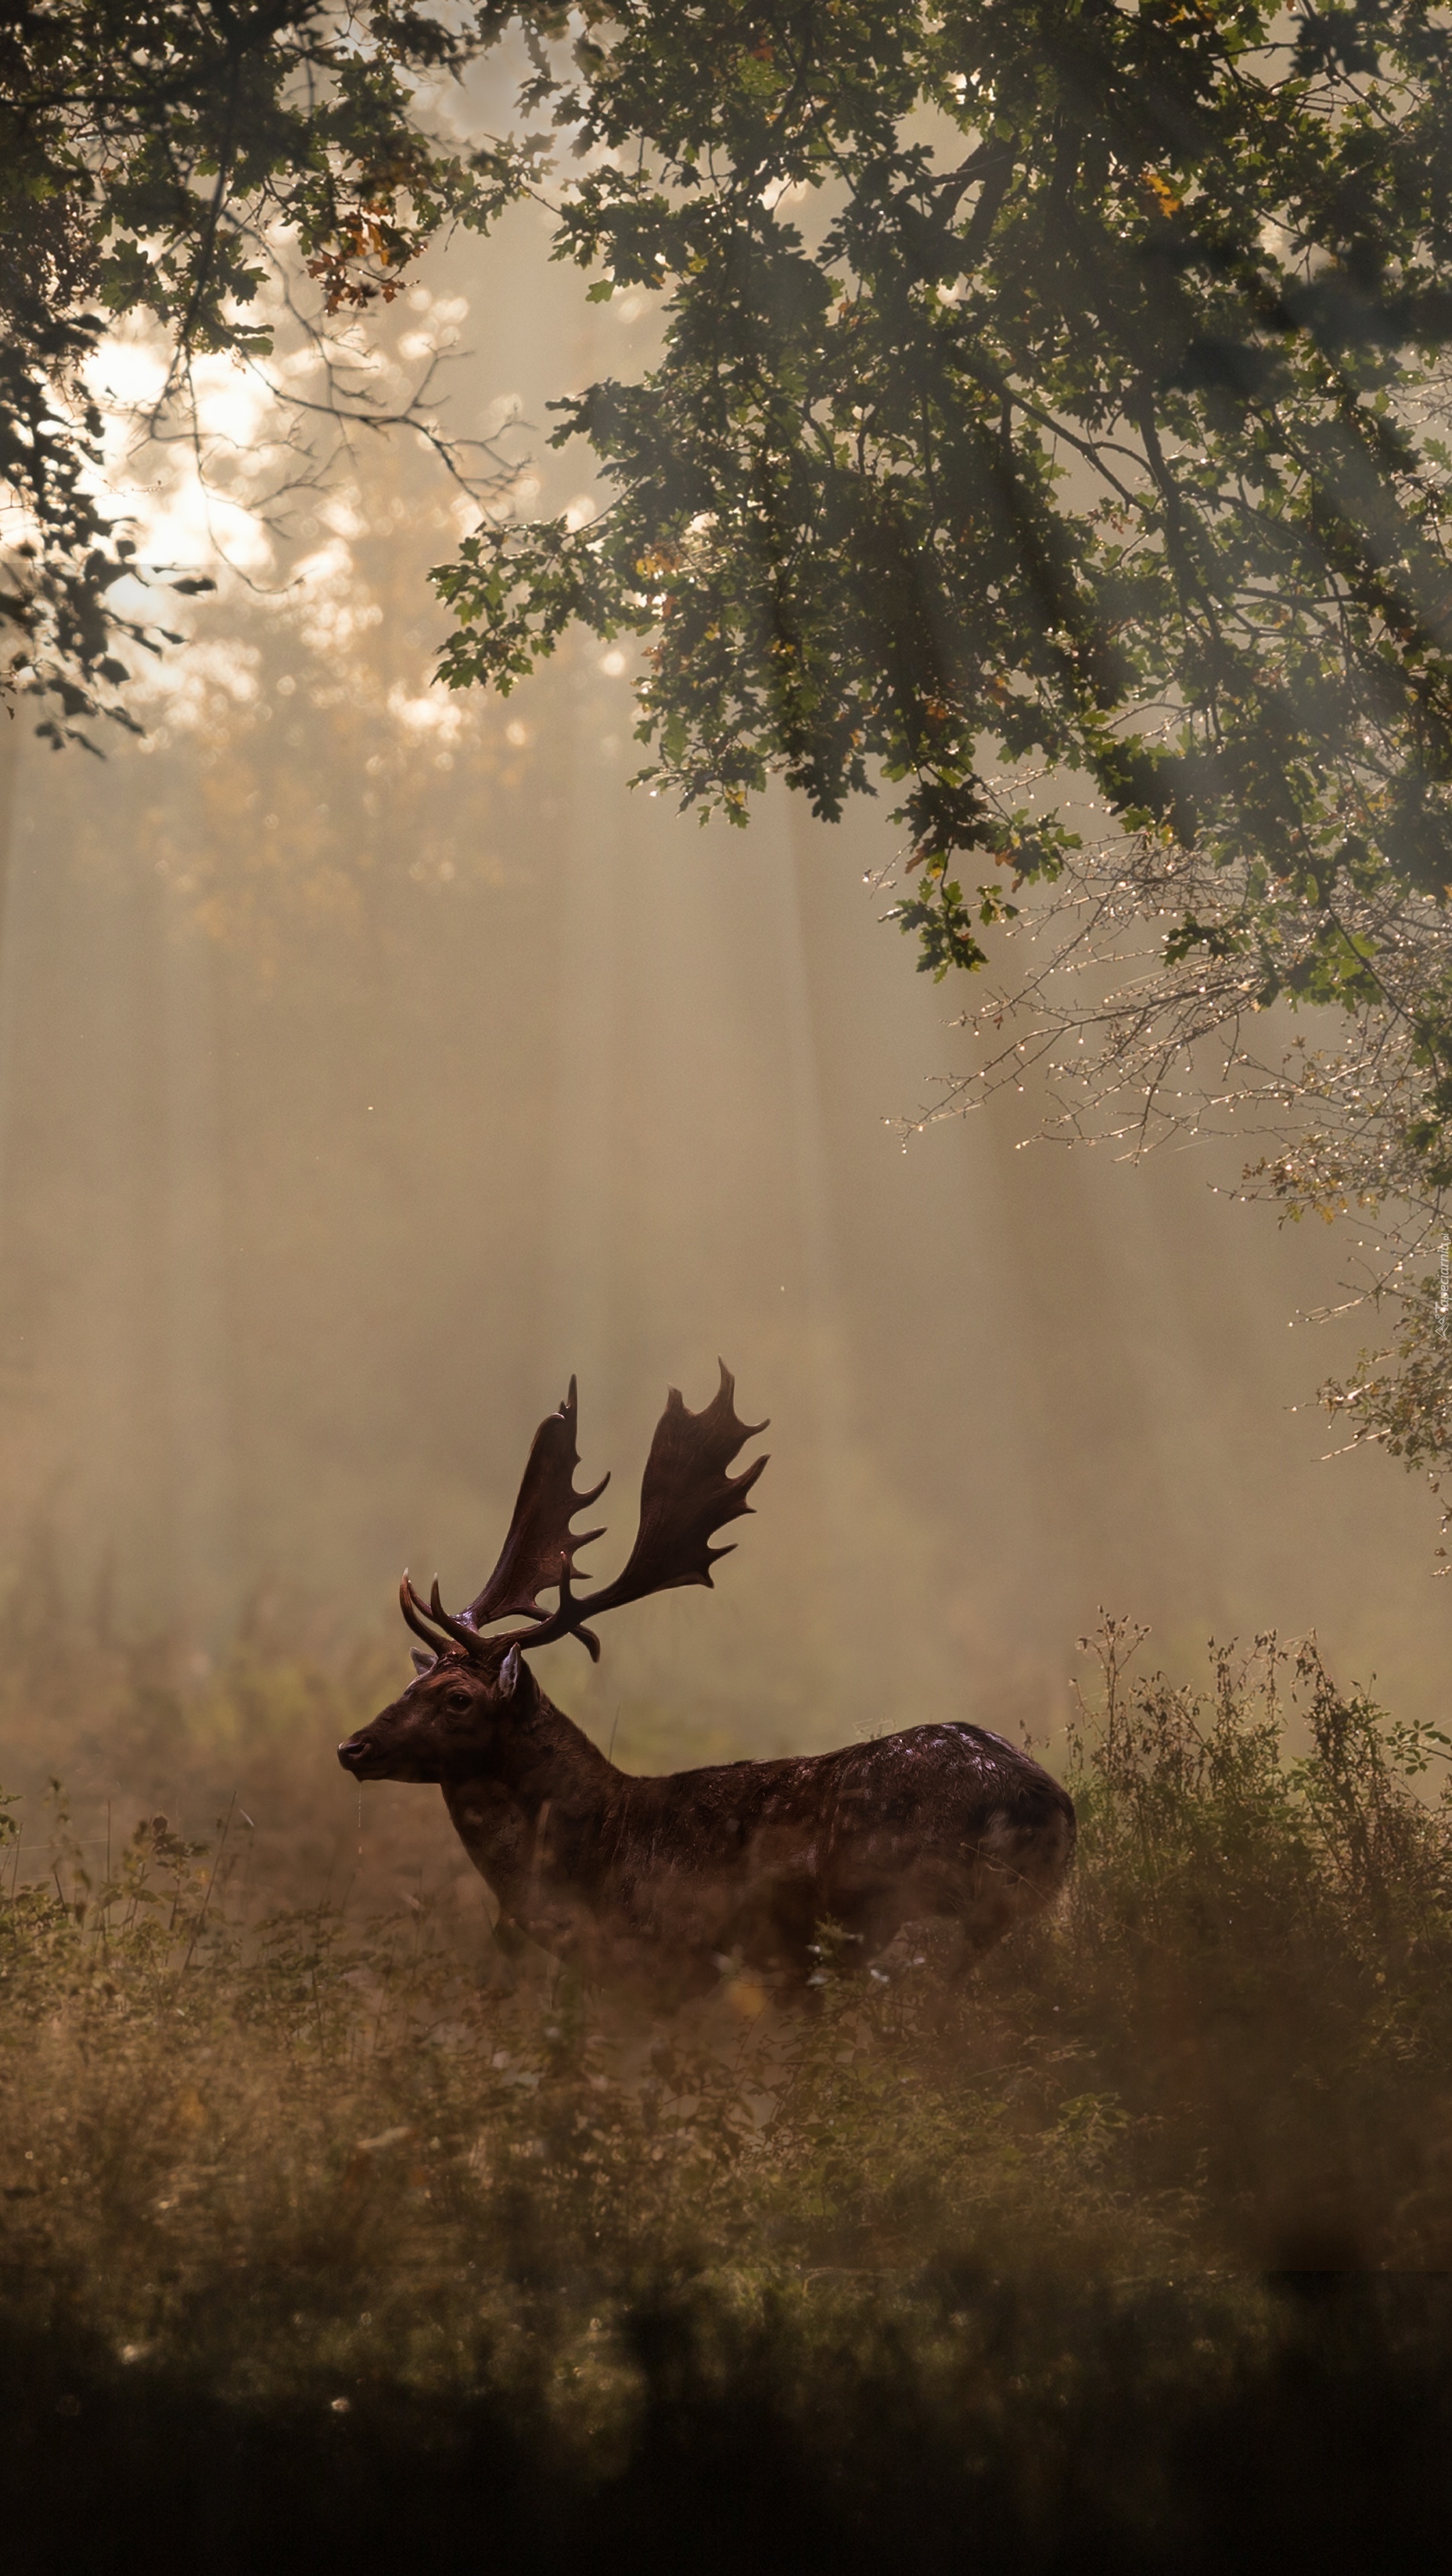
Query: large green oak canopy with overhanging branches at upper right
xmin=440 ymin=0 xmax=1452 ymax=1000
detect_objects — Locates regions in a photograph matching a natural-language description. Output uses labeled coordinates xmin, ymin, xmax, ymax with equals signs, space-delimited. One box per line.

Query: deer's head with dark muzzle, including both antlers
xmin=338 ymin=1360 xmax=767 ymax=1782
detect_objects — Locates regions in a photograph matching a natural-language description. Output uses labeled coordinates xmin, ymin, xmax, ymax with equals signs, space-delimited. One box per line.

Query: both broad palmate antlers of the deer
xmin=399 ymin=1360 xmax=767 ymax=1662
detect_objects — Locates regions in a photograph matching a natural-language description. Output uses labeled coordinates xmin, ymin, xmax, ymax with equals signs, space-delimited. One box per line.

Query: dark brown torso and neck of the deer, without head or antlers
xmin=443 ymin=1693 xmax=1074 ymax=1994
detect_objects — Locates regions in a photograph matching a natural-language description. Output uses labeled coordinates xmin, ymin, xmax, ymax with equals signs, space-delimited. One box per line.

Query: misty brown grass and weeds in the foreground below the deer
xmin=0 ymin=1623 xmax=1452 ymax=2571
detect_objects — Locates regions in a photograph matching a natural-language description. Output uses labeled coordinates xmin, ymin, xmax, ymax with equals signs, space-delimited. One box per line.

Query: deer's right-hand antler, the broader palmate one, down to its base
xmin=520 ymin=1360 xmax=767 ymax=1656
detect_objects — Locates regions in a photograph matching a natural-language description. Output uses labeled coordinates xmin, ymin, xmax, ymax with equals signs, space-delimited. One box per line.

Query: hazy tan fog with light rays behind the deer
xmin=0 ymin=191 xmax=1452 ymax=1760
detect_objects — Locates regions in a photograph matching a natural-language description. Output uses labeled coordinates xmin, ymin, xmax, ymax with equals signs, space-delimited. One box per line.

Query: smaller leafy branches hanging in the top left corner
xmin=0 ymin=0 xmax=507 ymax=747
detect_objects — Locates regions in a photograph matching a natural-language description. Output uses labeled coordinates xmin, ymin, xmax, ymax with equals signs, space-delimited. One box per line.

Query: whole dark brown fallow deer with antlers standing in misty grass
xmin=338 ymin=1362 xmax=1074 ymax=1996
